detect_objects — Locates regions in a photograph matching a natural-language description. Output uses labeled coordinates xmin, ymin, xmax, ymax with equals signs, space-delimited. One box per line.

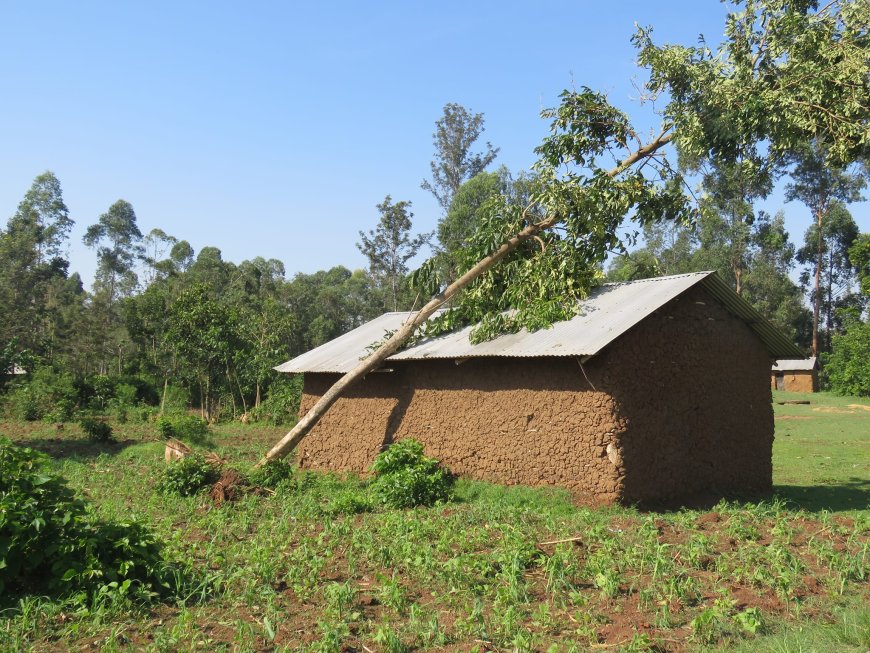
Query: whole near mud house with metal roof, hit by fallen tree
xmin=276 ymin=272 xmax=800 ymax=503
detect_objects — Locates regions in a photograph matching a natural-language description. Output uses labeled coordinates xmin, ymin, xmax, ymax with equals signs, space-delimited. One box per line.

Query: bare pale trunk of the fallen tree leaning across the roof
xmin=257 ymin=132 xmax=672 ymax=467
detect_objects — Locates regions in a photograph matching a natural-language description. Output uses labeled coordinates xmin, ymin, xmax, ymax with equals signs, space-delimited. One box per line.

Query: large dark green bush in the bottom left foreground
xmin=0 ymin=438 xmax=171 ymax=599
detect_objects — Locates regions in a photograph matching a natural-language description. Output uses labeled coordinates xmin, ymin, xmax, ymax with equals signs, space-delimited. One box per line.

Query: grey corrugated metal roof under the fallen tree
xmin=275 ymin=272 xmax=800 ymax=373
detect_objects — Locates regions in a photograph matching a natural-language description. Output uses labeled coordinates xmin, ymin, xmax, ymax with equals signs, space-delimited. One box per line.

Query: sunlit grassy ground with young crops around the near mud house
xmin=0 ymin=393 xmax=870 ymax=653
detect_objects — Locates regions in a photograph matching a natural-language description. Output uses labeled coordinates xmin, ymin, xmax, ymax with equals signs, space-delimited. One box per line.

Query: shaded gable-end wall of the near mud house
xmin=606 ymin=287 xmax=773 ymax=503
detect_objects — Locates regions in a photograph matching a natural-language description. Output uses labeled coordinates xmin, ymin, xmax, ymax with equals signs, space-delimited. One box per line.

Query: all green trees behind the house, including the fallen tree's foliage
xmin=0 ymin=2 xmax=870 ymax=418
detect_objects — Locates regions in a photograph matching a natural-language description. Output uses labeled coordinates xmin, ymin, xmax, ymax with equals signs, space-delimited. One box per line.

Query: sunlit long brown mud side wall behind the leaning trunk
xmin=299 ymin=358 xmax=625 ymax=502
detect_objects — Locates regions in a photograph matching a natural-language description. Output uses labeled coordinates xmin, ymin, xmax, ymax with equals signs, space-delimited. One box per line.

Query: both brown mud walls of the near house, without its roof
xmin=298 ymin=282 xmax=773 ymax=503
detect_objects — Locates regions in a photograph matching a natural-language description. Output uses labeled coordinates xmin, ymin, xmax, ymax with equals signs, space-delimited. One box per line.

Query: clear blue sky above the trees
xmin=0 ymin=0 xmax=870 ymax=283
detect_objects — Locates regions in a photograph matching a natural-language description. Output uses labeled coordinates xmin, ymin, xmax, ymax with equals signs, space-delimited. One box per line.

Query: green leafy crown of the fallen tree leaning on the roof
xmin=412 ymin=0 xmax=870 ymax=341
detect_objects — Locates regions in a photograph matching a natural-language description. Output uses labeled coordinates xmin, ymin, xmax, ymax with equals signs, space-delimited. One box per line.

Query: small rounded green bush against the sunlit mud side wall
xmin=372 ymin=439 xmax=453 ymax=508
